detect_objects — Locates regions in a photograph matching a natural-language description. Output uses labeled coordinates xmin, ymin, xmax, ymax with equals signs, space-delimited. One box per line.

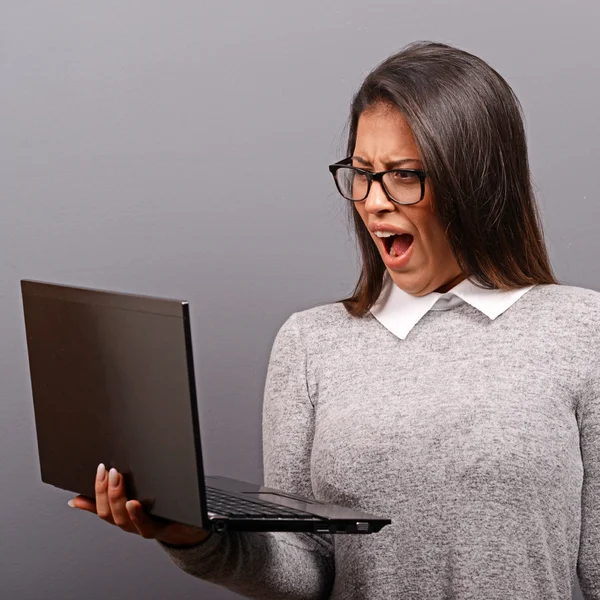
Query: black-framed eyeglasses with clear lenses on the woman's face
xmin=329 ymin=158 xmax=427 ymax=205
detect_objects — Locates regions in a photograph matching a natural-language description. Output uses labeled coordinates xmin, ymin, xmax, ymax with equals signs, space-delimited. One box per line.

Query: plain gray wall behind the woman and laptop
xmin=0 ymin=0 xmax=600 ymax=600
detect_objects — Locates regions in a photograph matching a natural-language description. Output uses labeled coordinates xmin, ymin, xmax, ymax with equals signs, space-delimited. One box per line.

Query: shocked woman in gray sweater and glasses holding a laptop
xmin=69 ymin=43 xmax=600 ymax=600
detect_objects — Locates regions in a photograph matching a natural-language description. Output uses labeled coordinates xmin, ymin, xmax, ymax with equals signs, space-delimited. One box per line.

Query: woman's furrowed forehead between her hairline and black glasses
xmin=354 ymin=105 xmax=420 ymax=161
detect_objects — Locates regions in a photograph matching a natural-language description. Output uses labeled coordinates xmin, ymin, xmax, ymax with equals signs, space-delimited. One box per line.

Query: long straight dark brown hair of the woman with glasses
xmin=340 ymin=42 xmax=558 ymax=317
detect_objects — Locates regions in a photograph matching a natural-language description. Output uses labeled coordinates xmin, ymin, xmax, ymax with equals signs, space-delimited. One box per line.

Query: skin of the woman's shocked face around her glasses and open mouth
xmin=352 ymin=105 xmax=464 ymax=296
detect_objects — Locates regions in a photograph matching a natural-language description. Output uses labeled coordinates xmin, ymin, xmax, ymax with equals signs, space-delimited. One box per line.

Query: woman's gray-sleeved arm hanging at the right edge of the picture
xmin=577 ymin=352 xmax=600 ymax=600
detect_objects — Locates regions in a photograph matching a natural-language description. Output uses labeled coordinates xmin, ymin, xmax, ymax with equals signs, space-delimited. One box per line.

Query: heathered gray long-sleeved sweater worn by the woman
xmin=160 ymin=285 xmax=600 ymax=600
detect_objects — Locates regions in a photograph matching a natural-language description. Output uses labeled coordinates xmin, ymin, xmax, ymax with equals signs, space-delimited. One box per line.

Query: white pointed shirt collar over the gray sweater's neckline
xmin=371 ymin=271 xmax=535 ymax=340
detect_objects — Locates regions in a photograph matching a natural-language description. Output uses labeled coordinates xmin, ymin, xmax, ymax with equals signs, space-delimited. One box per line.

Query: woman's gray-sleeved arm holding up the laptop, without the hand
xmin=159 ymin=315 xmax=334 ymax=600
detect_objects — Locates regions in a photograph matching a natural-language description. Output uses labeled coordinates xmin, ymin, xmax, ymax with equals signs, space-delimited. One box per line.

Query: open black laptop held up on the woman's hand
xmin=21 ymin=280 xmax=391 ymax=534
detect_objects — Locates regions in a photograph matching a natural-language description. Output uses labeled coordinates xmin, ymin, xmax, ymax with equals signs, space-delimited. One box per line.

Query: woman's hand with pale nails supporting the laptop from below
xmin=69 ymin=464 xmax=210 ymax=546
